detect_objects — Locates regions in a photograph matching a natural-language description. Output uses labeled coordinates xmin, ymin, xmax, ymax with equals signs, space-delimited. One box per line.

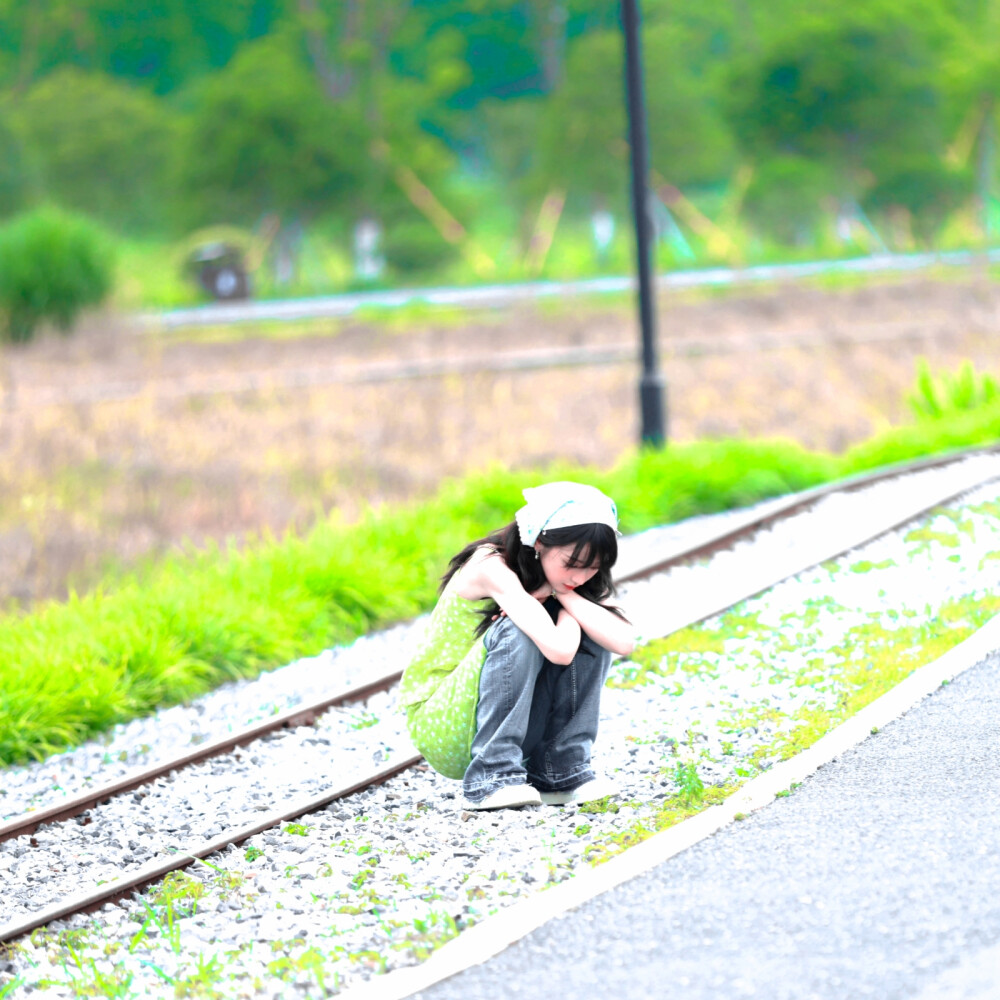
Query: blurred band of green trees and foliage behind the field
xmin=0 ymin=0 xmax=1000 ymax=304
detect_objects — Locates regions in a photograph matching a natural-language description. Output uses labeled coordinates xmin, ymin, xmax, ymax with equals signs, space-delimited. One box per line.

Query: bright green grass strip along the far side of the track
xmin=0 ymin=405 xmax=1000 ymax=764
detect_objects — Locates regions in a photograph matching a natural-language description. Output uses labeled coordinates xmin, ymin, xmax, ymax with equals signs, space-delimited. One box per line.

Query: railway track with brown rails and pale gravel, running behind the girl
xmin=0 ymin=450 xmax=1000 ymax=985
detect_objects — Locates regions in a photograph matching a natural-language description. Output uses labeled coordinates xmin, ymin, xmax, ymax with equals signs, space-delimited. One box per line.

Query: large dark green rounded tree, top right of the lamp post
xmin=725 ymin=0 xmax=962 ymax=240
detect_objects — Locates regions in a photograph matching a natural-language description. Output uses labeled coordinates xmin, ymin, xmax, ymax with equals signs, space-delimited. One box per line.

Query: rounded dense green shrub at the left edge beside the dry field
xmin=0 ymin=208 xmax=112 ymax=341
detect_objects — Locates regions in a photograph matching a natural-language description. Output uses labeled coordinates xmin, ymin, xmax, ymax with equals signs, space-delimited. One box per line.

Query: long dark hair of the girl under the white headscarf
xmin=441 ymin=521 xmax=624 ymax=637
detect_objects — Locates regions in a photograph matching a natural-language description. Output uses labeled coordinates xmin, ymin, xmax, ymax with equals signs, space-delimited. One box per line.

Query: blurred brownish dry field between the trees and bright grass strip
xmin=0 ymin=275 xmax=1000 ymax=605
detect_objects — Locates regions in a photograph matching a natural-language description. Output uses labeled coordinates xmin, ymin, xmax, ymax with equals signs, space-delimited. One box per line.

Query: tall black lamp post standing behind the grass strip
xmin=621 ymin=0 xmax=666 ymax=448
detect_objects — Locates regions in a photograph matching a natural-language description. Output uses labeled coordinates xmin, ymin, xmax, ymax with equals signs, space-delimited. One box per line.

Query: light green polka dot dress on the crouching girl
xmin=399 ymin=577 xmax=486 ymax=778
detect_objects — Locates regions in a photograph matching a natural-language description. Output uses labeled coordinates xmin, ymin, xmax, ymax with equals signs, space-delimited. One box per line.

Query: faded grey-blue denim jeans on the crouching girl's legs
xmin=463 ymin=618 xmax=611 ymax=802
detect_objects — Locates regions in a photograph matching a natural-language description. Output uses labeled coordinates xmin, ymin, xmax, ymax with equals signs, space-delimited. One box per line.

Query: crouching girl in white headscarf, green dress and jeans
xmin=400 ymin=482 xmax=634 ymax=809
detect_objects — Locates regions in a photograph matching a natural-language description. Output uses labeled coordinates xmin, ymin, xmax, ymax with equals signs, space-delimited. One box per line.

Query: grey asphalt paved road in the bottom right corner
xmin=417 ymin=654 xmax=1000 ymax=1000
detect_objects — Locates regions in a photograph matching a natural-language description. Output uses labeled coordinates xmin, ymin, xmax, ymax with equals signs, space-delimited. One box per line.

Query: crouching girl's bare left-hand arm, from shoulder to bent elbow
xmin=457 ymin=550 xmax=580 ymax=665
